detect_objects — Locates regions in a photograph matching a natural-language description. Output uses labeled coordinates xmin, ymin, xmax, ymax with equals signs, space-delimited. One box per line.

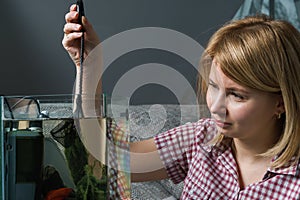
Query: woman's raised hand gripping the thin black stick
xmin=62 ymin=4 xmax=100 ymax=67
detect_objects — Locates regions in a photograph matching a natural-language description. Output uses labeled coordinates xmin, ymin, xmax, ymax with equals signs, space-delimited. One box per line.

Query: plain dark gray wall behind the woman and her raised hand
xmin=0 ymin=0 xmax=242 ymax=103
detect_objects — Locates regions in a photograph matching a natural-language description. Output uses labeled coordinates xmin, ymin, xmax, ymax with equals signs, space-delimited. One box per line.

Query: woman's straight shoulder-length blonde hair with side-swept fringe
xmin=198 ymin=16 xmax=300 ymax=168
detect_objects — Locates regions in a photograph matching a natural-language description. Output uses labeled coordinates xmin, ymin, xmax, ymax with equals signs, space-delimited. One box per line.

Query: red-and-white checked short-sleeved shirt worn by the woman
xmin=155 ymin=119 xmax=300 ymax=200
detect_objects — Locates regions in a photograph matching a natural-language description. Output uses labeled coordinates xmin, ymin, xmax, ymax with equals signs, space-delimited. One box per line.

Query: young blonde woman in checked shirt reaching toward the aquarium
xmin=63 ymin=3 xmax=300 ymax=200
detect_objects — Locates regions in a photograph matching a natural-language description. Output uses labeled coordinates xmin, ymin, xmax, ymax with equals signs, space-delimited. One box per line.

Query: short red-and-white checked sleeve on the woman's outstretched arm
xmin=154 ymin=119 xmax=216 ymax=183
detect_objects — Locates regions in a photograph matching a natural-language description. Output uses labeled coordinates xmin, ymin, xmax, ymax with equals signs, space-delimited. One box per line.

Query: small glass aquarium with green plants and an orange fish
xmin=0 ymin=95 xmax=130 ymax=200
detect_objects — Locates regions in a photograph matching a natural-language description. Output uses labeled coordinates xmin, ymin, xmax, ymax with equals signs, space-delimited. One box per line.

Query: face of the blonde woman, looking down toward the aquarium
xmin=206 ymin=62 xmax=282 ymax=140
